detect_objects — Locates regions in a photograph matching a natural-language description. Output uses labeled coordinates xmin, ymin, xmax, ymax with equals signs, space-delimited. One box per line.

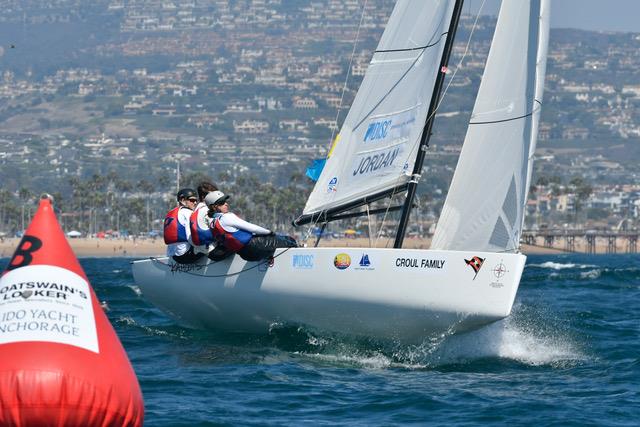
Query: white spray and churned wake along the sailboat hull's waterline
xmin=290 ymin=308 xmax=587 ymax=369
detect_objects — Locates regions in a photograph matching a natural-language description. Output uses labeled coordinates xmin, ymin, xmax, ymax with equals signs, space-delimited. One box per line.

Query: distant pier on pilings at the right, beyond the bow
xmin=522 ymin=229 xmax=640 ymax=254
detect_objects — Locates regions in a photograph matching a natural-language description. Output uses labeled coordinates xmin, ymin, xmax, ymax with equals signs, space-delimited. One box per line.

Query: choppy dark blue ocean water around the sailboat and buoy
xmin=2 ymin=255 xmax=640 ymax=426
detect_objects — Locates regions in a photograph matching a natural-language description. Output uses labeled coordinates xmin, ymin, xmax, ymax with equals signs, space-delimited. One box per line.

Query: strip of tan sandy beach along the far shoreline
xmin=0 ymin=238 xmax=627 ymax=258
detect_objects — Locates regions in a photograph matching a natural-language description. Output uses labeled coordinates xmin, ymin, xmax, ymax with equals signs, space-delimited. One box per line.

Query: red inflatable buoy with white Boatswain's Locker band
xmin=0 ymin=198 xmax=144 ymax=426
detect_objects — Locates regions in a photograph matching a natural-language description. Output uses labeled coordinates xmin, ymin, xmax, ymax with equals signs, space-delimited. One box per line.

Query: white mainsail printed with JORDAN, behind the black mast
xmin=303 ymin=0 xmax=455 ymax=214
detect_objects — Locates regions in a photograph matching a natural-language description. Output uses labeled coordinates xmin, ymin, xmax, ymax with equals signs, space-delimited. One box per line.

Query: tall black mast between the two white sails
xmin=393 ymin=0 xmax=464 ymax=248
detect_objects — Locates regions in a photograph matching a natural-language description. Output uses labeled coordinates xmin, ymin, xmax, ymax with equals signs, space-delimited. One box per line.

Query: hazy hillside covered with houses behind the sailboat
xmin=0 ymin=0 xmax=640 ymax=236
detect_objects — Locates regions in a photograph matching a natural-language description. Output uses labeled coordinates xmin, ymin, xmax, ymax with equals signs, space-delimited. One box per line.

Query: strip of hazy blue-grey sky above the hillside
xmin=464 ymin=0 xmax=640 ymax=33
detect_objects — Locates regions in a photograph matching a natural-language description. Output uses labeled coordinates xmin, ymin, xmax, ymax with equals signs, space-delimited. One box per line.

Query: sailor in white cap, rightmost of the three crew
xmin=204 ymin=191 xmax=297 ymax=261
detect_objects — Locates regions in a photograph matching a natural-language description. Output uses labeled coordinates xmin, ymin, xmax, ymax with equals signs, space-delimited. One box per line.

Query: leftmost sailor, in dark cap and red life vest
xmin=164 ymin=188 xmax=204 ymax=264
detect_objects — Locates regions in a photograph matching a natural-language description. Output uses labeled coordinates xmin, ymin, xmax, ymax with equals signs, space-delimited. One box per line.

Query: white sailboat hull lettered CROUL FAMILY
xmin=133 ymin=248 xmax=526 ymax=342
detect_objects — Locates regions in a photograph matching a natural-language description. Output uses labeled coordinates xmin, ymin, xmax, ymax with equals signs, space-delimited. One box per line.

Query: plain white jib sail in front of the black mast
xmin=431 ymin=0 xmax=549 ymax=252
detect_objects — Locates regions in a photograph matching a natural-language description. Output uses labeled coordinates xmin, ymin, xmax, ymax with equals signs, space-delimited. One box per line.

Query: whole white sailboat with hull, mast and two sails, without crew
xmin=133 ymin=0 xmax=549 ymax=342
